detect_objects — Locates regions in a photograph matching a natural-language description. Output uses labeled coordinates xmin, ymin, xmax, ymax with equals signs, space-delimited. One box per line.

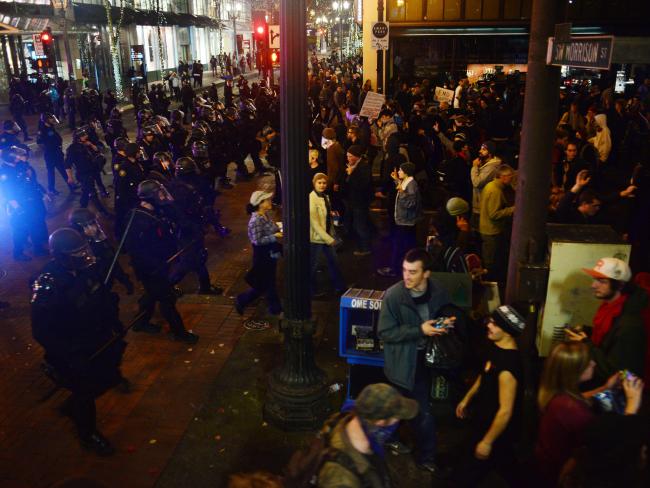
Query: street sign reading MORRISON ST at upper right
xmin=546 ymin=36 xmax=614 ymax=69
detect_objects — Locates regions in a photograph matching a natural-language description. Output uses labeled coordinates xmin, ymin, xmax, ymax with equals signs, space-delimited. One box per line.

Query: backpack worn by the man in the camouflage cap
xmin=284 ymin=412 xmax=363 ymax=488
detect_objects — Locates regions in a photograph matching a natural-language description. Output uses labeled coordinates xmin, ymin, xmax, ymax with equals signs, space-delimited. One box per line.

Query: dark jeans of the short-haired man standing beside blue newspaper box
xmin=394 ymin=350 xmax=437 ymax=464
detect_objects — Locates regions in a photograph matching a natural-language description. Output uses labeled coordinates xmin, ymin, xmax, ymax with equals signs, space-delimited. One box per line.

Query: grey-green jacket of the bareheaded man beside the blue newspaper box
xmin=377 ymin=279 xmax=449 ymax=391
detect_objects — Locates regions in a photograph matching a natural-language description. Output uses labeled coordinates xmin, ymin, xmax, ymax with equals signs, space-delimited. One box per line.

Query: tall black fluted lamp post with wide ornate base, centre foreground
xmin=264 ymin=0 xmax=330 ymax=430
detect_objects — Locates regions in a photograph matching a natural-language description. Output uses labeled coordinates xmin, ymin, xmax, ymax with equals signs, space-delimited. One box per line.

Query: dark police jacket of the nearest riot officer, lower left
xmin=31 ymin=261 xmax=123 ymax=374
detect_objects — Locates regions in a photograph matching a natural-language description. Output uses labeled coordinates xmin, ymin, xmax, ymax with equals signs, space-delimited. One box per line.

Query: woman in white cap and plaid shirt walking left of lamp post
xmin=235 ymin=190 xmax=282 ymax=315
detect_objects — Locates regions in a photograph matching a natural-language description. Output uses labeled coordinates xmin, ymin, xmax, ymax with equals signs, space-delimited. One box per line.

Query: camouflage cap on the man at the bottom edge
xmin=355 ymin=383 xmax=418 ymax=420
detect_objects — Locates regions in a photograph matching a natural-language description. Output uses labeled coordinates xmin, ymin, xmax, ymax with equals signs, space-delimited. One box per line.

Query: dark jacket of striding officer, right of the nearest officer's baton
xmin=126 ymin=205 xmax=177 ymax=279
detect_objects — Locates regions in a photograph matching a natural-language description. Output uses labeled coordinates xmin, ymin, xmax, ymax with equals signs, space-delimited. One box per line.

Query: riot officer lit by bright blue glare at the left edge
xmin=0 ymin=146 xmax=47 ymax=261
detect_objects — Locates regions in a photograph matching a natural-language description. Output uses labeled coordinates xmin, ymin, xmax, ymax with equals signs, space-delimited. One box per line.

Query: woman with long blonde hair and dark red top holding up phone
xmin=535 ymin=342 xmax=643 ymax=486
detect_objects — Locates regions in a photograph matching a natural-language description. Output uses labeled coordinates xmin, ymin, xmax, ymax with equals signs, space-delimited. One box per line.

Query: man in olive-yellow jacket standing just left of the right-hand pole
xmin=478 ymin=164 xmax=515 ymax=281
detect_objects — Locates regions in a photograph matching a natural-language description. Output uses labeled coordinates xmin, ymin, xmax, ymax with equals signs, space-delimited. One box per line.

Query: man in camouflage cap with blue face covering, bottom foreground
xmin=318 ymin=383 xmax=418 ymax=488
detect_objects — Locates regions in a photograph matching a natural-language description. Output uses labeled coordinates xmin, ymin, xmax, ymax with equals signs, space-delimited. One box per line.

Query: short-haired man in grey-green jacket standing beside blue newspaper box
xmin=378 ymin=249 xmax=455 ymax=474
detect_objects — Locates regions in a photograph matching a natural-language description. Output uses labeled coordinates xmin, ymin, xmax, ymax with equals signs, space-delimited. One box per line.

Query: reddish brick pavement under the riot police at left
xmin=0 ymin=112 xmax=278 ymax=487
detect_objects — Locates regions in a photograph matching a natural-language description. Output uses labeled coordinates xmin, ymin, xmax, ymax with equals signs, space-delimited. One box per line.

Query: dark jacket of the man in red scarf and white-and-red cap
xmin=587 ymin=285 xmax=649 ymax=381
